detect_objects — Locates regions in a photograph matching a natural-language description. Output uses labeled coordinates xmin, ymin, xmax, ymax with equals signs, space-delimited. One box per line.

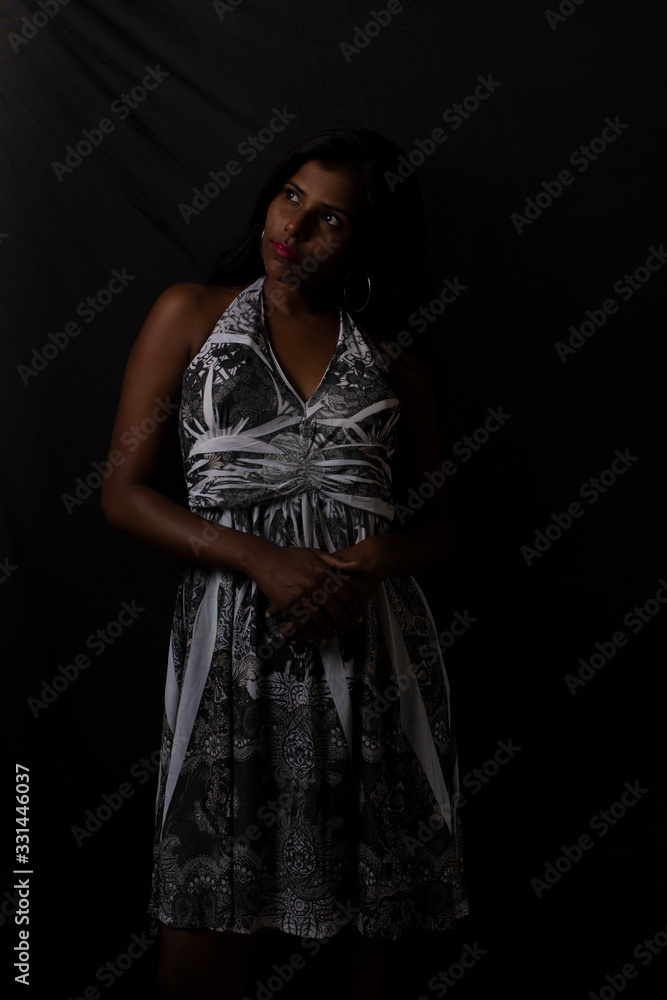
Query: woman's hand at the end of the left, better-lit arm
xmin=250 ymin=543 xmax=363 ymax=644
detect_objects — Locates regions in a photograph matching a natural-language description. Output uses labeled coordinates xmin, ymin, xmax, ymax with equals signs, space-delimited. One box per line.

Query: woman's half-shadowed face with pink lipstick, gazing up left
xmin=262 ymin=160 xmax=360 ymax=289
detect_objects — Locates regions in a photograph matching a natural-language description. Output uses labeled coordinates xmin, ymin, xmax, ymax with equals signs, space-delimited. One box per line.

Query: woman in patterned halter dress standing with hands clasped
xmin=102 ymin=128 xmax=467 ymax=1000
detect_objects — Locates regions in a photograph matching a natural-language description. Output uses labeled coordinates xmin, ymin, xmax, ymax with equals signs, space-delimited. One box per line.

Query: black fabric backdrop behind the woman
xmin=0 ymin=0 xmax=667 ymax=1000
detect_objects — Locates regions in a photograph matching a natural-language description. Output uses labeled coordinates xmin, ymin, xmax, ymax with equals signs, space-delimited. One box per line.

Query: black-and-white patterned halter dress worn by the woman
xmin=149 ymin=277 xmax=468 ymax=939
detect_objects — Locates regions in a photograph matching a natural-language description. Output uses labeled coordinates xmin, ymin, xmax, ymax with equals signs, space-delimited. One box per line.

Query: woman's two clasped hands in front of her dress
xmin=255 ymin=536 xmax=383 ymax=645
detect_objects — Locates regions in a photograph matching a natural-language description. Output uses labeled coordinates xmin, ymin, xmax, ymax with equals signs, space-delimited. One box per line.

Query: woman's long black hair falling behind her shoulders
xmin=207 ymin=127 xmax=446 ymax=372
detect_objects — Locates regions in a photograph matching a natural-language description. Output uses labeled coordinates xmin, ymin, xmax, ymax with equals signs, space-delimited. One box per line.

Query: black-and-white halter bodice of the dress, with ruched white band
xmin=179 ymin=276 xmax=400 ymax=521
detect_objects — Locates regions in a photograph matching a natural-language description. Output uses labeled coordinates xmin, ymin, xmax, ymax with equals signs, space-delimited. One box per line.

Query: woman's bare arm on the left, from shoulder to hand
xmin=101 ymin=284 xmax=363 ymax=637
